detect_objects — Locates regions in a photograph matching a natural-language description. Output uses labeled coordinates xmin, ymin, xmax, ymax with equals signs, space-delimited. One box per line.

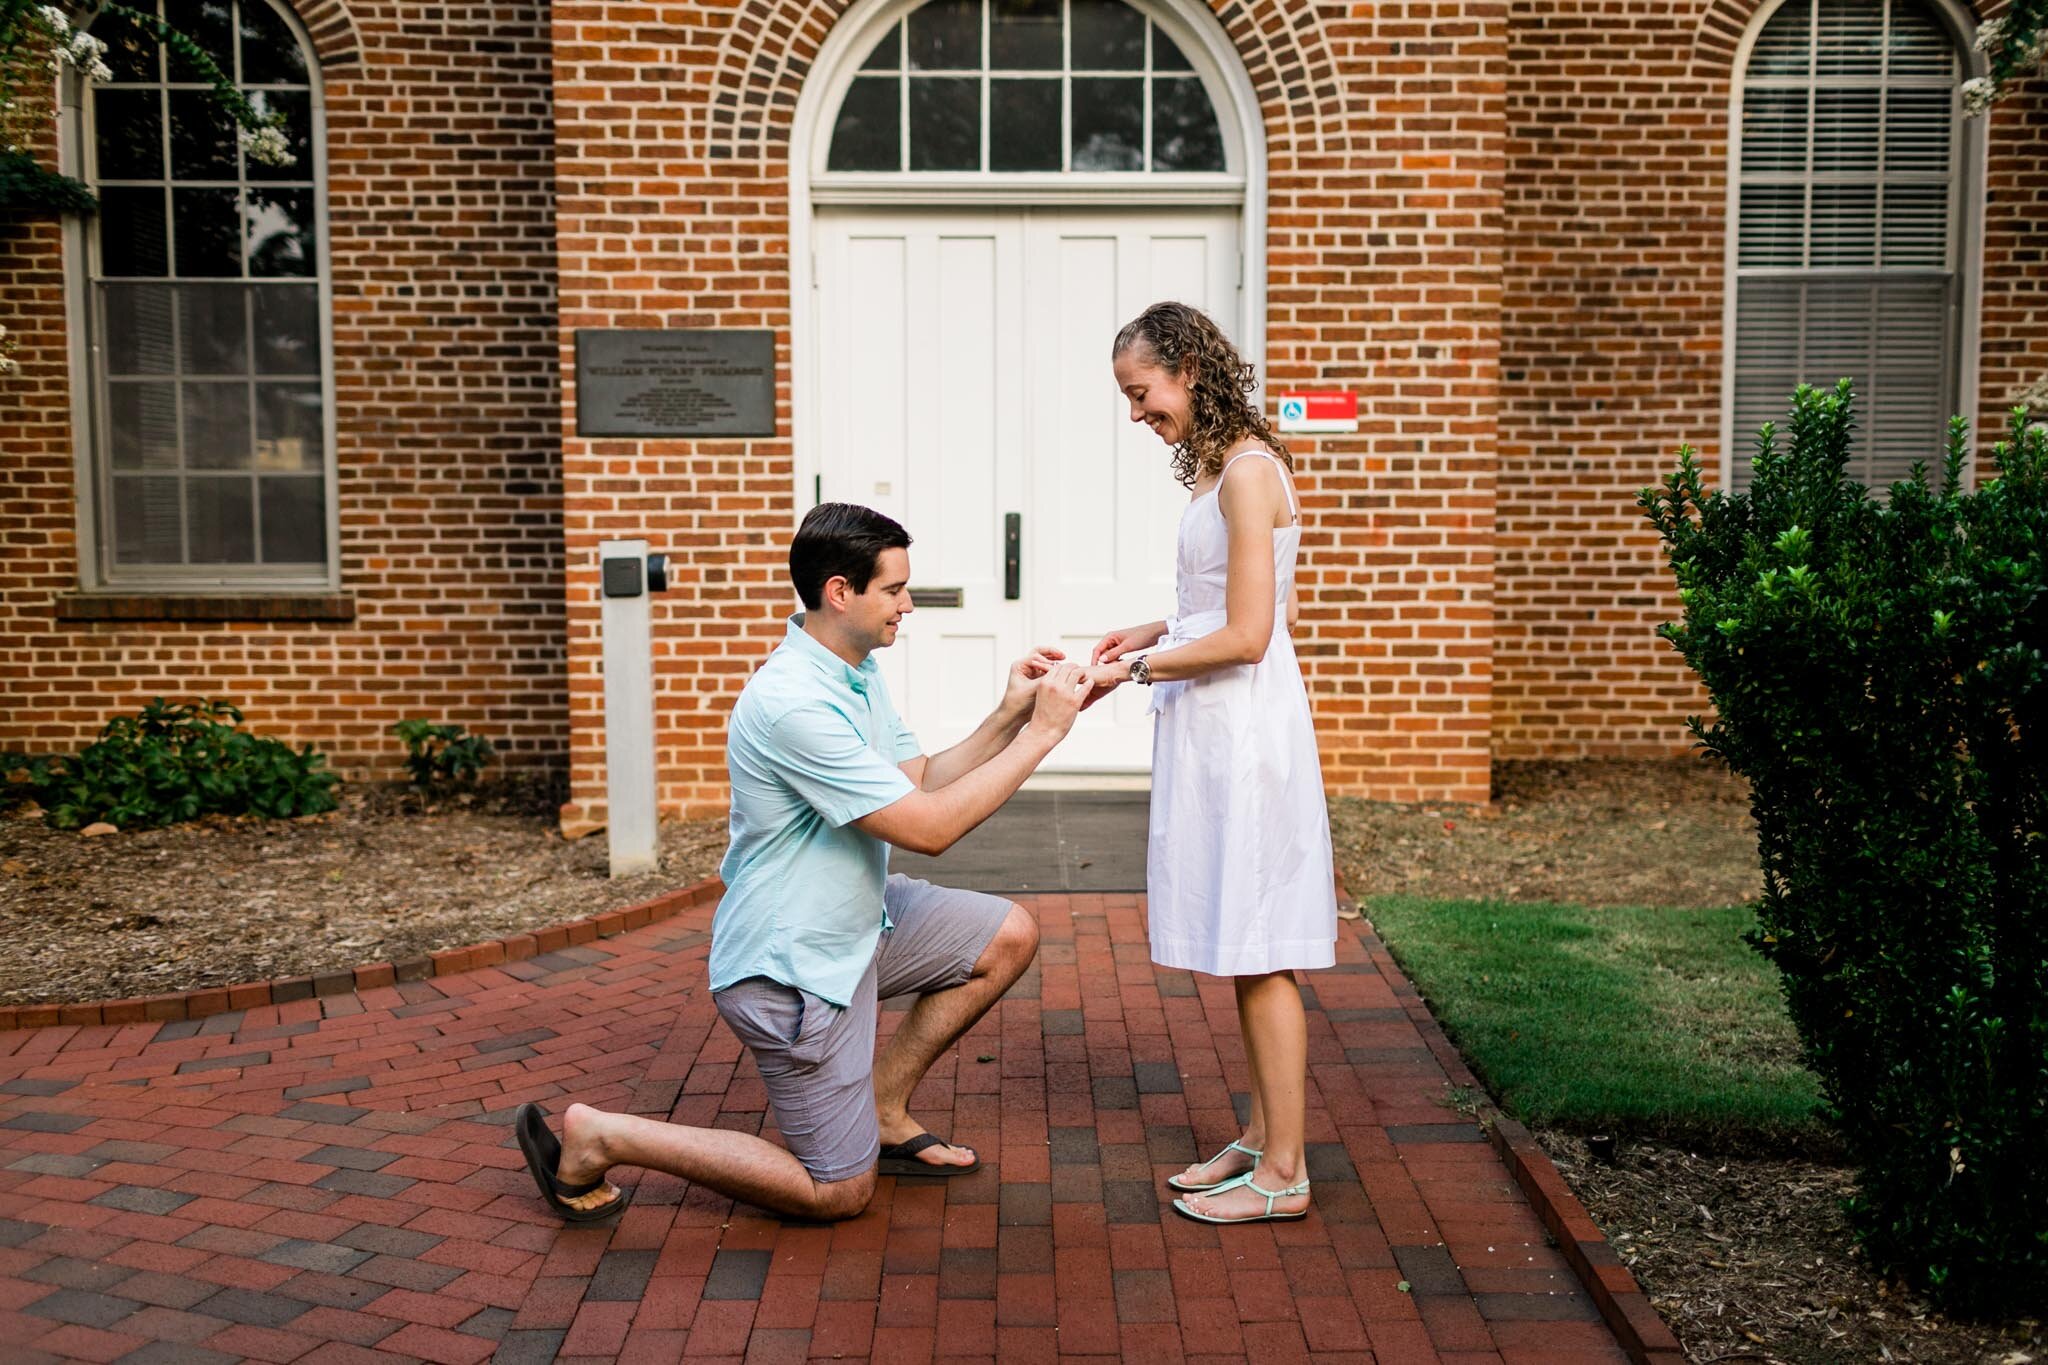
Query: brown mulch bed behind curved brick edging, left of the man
xmin=0 ymin=782 xmax=725 ymax=1005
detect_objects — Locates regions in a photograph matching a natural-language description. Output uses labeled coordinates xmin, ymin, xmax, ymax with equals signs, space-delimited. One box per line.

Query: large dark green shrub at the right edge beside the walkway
xmin=1640 ymin=381 xmax=2048 ymax=1312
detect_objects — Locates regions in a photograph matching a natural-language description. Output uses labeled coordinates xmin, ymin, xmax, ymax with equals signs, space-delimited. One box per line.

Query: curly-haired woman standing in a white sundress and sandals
xmin=1092 ymin=303 xmax=1337 ymax=1222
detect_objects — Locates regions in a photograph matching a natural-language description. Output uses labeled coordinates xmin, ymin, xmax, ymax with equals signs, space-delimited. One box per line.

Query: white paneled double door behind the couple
xmin=815 ymin=209 xmax=1239 ymax=772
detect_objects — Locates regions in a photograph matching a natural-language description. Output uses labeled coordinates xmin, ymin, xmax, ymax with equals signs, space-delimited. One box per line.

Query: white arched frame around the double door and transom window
xmin=788 ymin=0 xmax=1266 ymax=524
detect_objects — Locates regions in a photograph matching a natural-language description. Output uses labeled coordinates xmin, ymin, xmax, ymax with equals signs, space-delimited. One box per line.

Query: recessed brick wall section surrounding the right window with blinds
xmin=1493 ymin=0 xmax=2048 ymax=757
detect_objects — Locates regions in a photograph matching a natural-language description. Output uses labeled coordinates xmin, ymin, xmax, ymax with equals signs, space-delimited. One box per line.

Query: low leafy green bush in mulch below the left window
xmin=0 ymin=698 xmax=340 ymax=829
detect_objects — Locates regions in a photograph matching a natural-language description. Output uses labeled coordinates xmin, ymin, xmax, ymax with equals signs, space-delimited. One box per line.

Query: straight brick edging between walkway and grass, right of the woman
xmin=1337 ymin=876 xmax=1686 ymax=1365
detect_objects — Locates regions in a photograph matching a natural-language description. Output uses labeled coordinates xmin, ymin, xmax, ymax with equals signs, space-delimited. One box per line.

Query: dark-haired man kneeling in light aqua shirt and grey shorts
xmin=516 ymin=503 xmax=1085 ymax=1222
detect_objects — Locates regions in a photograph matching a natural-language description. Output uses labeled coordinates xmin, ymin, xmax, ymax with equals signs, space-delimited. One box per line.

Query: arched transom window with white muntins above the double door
xmin=825 ymin=0 xmax=1227 ymax=172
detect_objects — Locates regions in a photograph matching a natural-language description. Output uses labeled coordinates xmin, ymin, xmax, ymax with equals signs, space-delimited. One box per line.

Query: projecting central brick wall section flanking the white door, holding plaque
xmin=555 ymin=0 xmax=1505 ymax=829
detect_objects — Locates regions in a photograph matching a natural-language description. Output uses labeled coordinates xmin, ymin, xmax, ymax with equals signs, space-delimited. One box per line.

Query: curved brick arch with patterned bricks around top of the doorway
xmin=700 ymin=0 xmax=1366 ymax=162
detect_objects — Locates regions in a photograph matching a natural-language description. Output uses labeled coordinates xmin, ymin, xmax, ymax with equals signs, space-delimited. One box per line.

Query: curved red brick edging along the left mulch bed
xmin=0 ymin=876 xmax=723 ymax=1031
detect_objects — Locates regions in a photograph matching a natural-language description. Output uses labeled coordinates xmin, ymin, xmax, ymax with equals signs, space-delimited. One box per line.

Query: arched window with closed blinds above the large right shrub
xmin=1724 ymin=0 xmax=1972 ymax=487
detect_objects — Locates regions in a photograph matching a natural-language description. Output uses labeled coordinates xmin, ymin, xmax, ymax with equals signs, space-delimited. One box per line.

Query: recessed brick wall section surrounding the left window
xmin=0 ymin=0 xmax=565 ymax=776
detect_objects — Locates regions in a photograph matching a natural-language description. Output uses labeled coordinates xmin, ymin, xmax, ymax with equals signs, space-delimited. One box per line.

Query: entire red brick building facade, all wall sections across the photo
xmin=0 ymin=0 xmax=2048 ymax=829
